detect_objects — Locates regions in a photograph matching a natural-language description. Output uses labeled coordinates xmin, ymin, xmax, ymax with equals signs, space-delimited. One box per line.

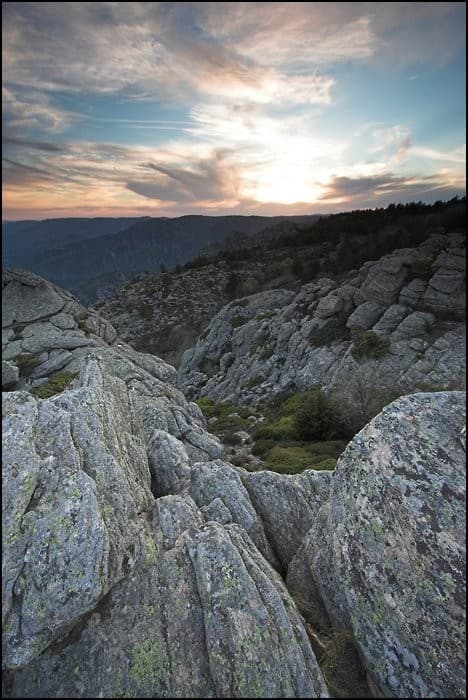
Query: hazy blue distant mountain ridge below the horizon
xmin=2 ymin=215 xmax=317 ymax=303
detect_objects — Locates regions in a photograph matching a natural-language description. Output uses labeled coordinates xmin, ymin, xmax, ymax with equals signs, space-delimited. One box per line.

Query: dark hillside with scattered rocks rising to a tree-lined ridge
xmin=95 ymin=201 xmax=465 ymax=365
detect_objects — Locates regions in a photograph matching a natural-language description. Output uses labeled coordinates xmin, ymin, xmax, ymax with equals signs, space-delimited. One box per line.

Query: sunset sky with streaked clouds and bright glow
xmin=2 ymin=2 xmax=466 ymax=220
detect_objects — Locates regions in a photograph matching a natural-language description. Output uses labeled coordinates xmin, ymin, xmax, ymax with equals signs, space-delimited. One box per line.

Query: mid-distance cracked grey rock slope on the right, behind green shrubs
xmin=179 ymin=234 xmax=465 ymax=404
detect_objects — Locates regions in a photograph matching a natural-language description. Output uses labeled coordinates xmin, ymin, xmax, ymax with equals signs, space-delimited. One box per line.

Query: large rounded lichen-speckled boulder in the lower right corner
xmin=288 ymin=392 xmax=466 ymax=697
